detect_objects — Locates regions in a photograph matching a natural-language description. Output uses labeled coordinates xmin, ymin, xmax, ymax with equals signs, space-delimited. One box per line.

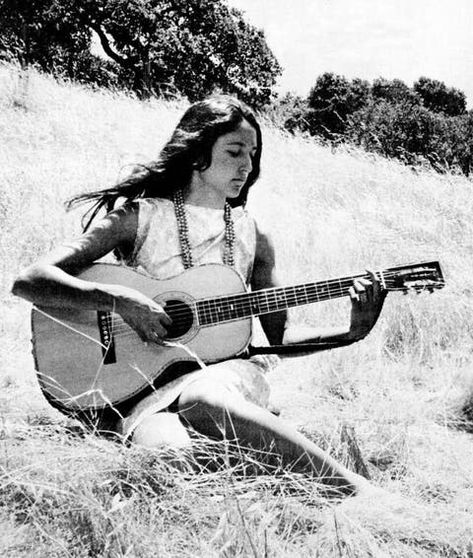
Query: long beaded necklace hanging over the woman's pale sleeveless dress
xmin=172 ymin=190 xmax=235 ymax=269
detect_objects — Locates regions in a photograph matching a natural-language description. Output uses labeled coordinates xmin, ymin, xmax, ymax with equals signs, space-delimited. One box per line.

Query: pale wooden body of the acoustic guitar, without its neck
xmin=32 ymin=264 xmax=252 ymax=410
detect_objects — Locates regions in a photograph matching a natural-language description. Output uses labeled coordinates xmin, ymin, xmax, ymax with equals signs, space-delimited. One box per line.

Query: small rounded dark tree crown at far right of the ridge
xmin=414 ymin=77 xmax=466 ymax=116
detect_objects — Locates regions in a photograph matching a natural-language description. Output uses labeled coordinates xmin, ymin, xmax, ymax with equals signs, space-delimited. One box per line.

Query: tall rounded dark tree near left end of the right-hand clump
xmin=306 ymin=73 xmax=370 ymax=138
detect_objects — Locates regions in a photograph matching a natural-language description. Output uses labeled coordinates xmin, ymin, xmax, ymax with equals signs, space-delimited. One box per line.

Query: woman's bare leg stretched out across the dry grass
xmin=178 ymin=379 xmax=370 ymax=494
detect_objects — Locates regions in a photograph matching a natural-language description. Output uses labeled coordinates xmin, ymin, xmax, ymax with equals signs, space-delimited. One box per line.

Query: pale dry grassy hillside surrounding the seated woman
xmin=0 ymin=66 xmax=473 ymax=557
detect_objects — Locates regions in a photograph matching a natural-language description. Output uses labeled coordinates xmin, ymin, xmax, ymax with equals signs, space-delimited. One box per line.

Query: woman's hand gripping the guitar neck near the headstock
xmin=350 ymin=270 xmax=387 ymax=340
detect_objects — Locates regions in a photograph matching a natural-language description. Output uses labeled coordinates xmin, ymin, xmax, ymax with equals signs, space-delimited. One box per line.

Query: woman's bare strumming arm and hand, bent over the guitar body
xmin=12 ymin=208 xmax=171 ymax=341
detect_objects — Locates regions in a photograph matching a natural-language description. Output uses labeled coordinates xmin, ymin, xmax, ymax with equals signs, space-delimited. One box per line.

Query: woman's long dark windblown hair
xmin=66 ymin=95 xmax=262 ymax=230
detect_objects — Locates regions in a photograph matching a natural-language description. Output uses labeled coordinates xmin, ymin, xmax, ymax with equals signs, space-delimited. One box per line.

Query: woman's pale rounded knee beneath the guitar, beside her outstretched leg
xmin=132 ymin=412 xmax=191 ymax=448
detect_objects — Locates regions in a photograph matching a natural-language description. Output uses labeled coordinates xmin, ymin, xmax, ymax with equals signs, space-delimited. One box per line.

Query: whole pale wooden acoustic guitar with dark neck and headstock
xmin=32 ymin=262 xmax=444 ymax=410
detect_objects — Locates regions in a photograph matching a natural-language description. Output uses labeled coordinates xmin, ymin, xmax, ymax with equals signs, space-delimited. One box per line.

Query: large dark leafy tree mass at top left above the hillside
xmin=0 ymin=0 xmax=281 ymax=107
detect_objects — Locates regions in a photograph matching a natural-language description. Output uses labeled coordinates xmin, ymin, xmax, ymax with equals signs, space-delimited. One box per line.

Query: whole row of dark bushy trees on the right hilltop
xmin=280 ymin=73 xmax=473 ymax=175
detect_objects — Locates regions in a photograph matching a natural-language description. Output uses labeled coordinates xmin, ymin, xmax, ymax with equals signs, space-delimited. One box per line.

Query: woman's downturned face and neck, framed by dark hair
xmin=191 ymin=120 xmax=258 ymax=208
